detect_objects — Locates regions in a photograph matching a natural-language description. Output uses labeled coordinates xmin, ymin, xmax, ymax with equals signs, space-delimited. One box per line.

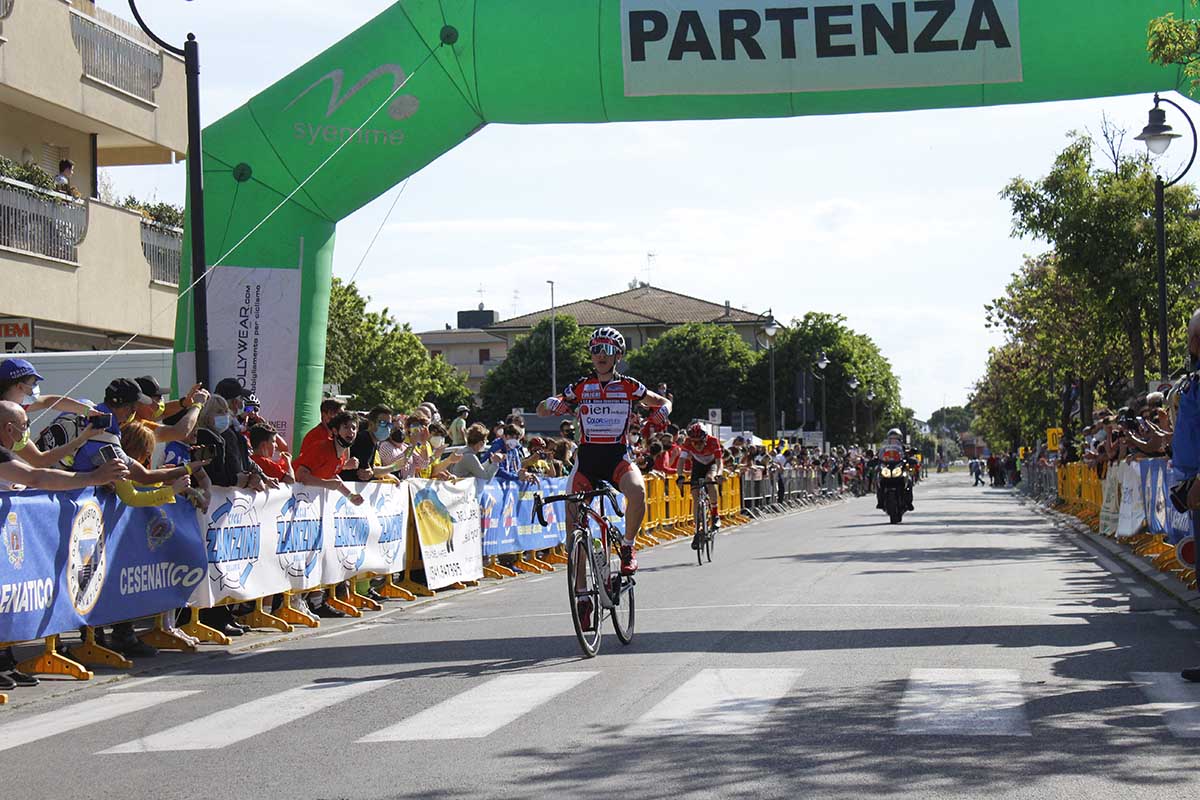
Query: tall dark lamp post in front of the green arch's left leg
xmin=130 ymin=0 xmax=209 ymax=384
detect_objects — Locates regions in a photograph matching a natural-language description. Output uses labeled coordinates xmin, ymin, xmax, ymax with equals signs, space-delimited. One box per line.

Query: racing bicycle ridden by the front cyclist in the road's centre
xmin=533 ymin=482 xmax=637 ymax=658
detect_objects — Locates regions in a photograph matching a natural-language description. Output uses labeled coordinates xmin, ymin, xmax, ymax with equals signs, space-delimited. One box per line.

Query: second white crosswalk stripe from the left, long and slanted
xmin=98 ymin=680 xmax=396 ymax=756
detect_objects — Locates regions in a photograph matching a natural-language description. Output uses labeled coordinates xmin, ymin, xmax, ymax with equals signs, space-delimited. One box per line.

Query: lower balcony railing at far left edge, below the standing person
xmin=0 ymin=178 xmax=88 ymax=264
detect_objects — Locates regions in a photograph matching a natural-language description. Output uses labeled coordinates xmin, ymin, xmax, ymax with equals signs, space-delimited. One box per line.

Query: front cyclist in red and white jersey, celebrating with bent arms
xmin=538 ymin=327 xmax=671 ymax=575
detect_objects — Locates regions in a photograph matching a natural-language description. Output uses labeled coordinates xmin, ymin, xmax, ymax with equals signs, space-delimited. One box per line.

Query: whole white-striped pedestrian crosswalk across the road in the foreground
xmin=0 ymin=668 xmax=1200 ymax=757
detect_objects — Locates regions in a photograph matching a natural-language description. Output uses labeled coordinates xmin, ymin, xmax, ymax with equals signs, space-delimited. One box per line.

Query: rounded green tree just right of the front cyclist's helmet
xmin=629 ymin=323 xmax=756 ymax=425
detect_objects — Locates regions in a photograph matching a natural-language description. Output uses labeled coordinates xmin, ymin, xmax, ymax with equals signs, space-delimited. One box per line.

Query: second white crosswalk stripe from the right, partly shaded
xmin=896 ymin=669 xmax=1031 ymax=736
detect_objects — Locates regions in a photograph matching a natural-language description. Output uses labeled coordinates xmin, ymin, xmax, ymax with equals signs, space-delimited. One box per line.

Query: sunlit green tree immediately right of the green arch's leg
xmin=325 ymin=278 xmax=470 ymax=411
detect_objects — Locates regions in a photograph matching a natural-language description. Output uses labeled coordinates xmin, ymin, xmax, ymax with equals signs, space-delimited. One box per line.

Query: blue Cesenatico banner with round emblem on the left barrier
xmin=0 ymin=489 xmax=204 ymax=642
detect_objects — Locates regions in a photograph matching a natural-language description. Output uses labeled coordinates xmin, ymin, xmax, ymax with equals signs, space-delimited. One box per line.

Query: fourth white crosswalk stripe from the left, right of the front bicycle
xmin=625 ymin=669 xmax=804 ymax=736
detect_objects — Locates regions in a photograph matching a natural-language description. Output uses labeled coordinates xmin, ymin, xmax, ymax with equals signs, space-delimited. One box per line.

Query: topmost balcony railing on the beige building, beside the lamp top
xmin=69 ymin=6 xmax=162 ymax=103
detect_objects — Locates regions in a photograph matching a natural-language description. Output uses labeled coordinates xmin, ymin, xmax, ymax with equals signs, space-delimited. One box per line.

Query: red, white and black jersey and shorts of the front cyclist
xmin=563 ymin=373 xmax=646 ymax=492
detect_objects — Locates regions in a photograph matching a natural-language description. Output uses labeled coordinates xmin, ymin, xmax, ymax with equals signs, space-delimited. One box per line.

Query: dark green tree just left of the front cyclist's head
xmin=480 ymin=314 xmax=592 ymax=422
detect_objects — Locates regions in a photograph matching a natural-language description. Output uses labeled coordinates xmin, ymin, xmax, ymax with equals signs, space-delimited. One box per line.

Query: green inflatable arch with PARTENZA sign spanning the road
xmin=175 ymin=0 xmax=1190 ymax=439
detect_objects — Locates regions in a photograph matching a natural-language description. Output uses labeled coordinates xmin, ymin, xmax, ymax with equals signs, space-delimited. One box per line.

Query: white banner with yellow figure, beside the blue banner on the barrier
xmin=406 ymin=479 xmax=484 ymax=589
